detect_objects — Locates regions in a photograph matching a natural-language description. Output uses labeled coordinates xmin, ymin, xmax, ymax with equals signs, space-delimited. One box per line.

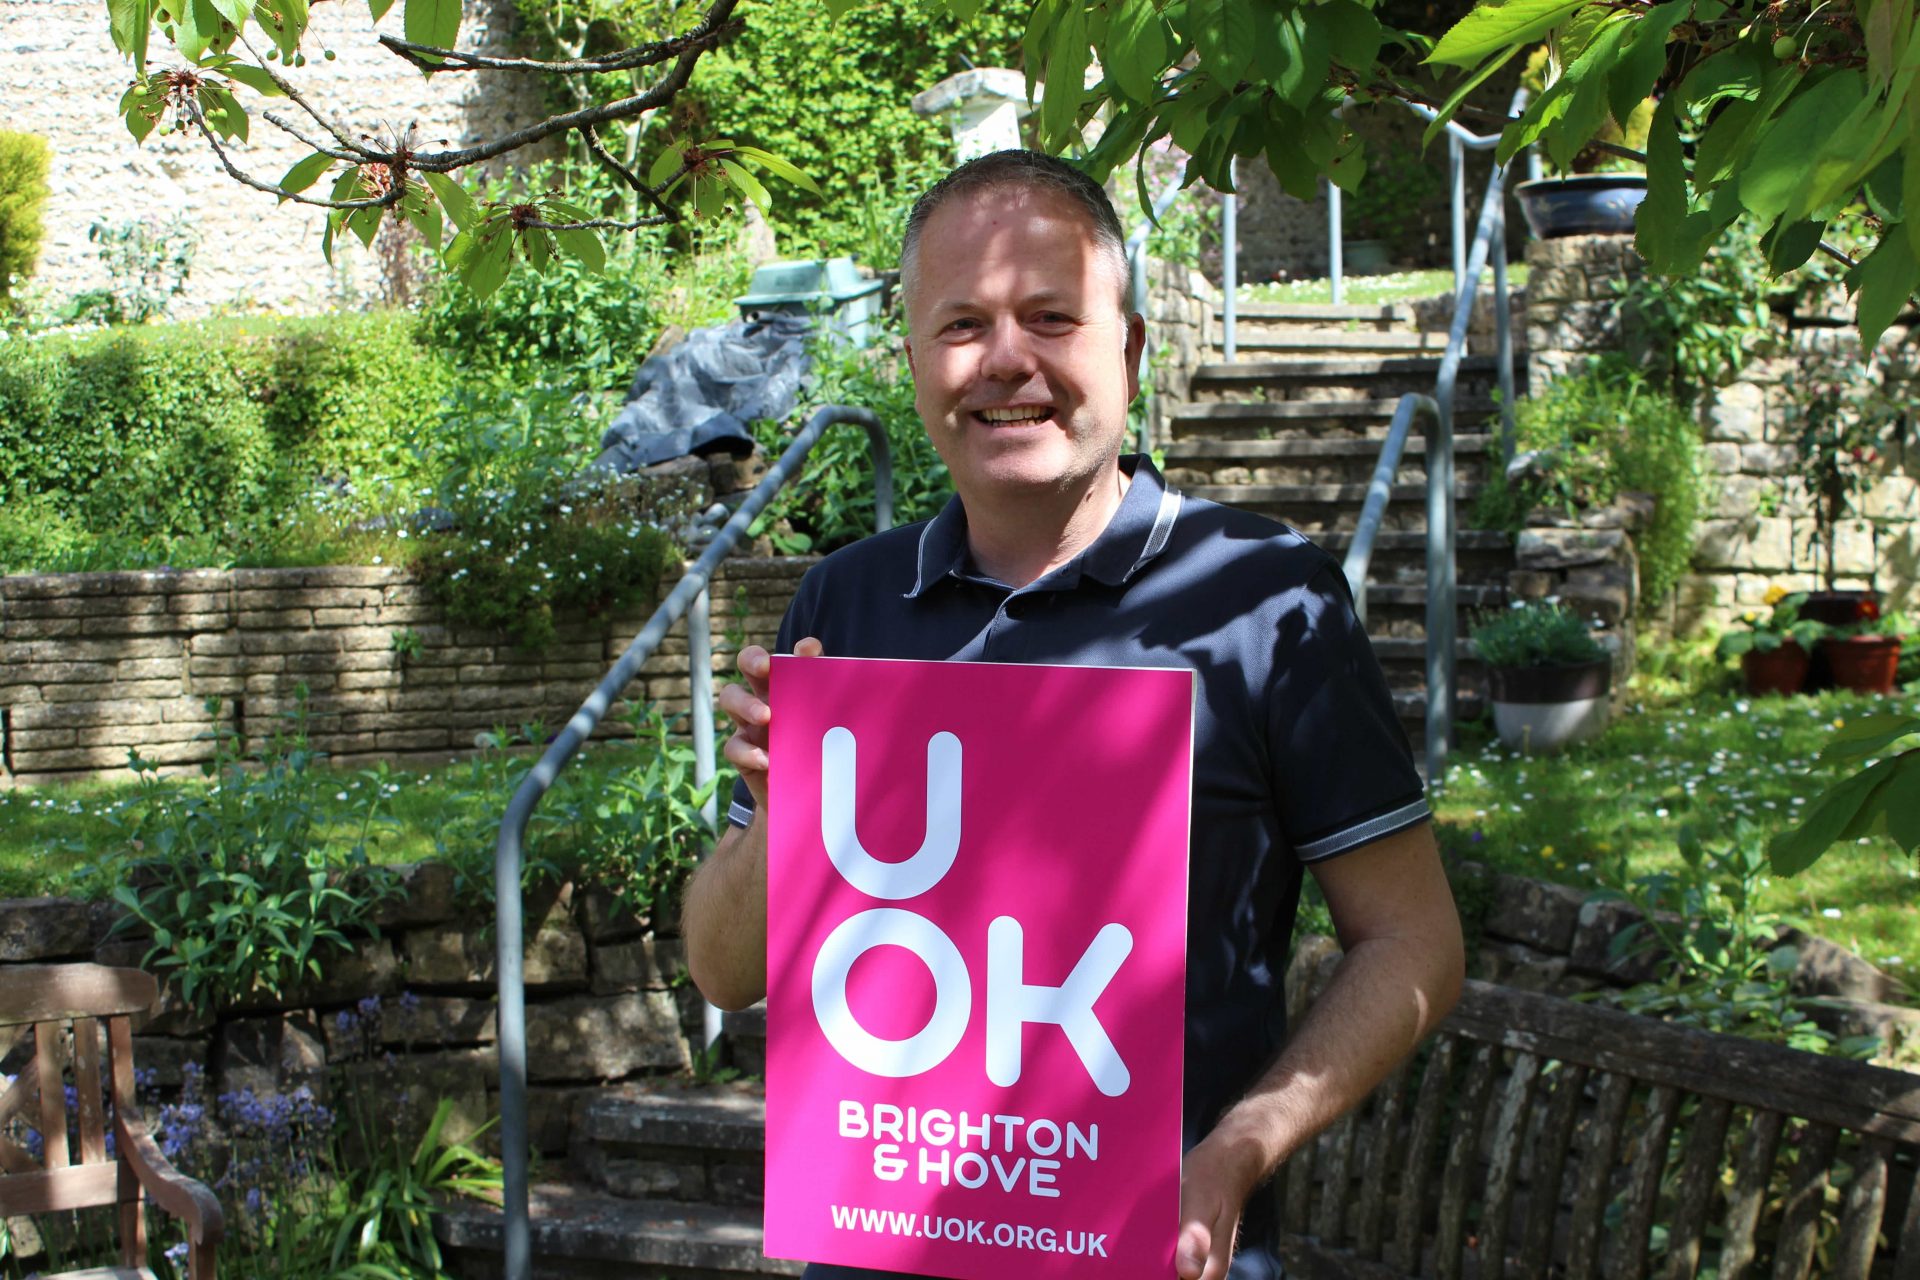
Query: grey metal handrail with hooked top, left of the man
xmin=493 ymin=405 xmax=893 ymax=1280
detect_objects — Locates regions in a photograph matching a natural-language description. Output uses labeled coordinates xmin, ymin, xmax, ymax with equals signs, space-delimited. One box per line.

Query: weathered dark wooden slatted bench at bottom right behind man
xmin=1275 ymin=963 xmax=1920 ymax=1280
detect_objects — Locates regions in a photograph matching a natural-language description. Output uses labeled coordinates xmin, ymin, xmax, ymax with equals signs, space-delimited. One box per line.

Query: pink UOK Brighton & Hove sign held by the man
xmin=766 ymin=658 xmax=1192 ymax=1280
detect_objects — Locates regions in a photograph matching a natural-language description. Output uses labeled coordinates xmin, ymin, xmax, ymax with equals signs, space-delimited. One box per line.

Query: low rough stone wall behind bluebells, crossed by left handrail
xmin=0 ymin=864 xmax=701 ymax=1155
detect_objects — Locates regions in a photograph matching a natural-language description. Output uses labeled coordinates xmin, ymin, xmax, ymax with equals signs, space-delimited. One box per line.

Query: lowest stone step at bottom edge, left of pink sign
xmin=434 ymin=1180 xmax=803 ymax=1280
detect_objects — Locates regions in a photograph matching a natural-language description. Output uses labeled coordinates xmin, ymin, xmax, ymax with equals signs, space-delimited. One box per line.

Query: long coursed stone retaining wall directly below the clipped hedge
xmin=0 ymin=557 xmax=812 ymax=785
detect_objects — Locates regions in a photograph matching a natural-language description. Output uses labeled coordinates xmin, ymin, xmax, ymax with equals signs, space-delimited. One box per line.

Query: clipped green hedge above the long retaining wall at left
xmin=0 ymin=315 xmax=451 ymax=572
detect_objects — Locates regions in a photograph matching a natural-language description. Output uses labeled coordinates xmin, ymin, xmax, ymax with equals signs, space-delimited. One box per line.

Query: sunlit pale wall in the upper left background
xmin=0 ymin=0 xmax=541 ymax=317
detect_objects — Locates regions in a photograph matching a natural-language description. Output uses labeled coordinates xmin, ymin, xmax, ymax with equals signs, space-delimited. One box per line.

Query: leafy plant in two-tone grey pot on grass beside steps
xmin=1473 ymin=601 xmax=1613 ymax=754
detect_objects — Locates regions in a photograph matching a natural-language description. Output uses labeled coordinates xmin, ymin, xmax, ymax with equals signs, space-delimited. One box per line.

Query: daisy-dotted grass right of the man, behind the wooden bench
xmin=1434 ymin=691 xmax=1920 ymax=977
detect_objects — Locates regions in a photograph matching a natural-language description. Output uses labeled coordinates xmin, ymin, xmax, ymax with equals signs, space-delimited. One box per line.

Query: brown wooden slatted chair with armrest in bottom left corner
xmin=0 ymin=965 xmax=221 ymax=1280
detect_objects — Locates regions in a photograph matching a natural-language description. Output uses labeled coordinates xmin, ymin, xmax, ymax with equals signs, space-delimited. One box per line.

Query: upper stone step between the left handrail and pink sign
xmin=574 ymin=1080 xmax=766 ymax=1205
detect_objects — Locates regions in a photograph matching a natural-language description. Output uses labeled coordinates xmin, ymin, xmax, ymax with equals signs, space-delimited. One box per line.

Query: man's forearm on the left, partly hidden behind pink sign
xmin=682 ymin=814 xmax=766 ymax=1009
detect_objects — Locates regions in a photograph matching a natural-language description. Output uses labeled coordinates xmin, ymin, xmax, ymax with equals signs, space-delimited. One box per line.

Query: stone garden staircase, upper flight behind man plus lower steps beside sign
xmin=438 ymin=307 xmax=1513 ymax=1280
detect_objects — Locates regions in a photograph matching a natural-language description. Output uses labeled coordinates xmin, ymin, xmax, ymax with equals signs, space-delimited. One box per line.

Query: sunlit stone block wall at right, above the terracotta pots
xmin=1526 ymin=236 xmax=1920 ymax=631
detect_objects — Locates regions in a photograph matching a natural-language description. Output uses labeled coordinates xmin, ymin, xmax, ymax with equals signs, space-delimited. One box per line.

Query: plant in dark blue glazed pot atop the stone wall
xmin=1513 ymin=46 xmax=1653 ymax=240
